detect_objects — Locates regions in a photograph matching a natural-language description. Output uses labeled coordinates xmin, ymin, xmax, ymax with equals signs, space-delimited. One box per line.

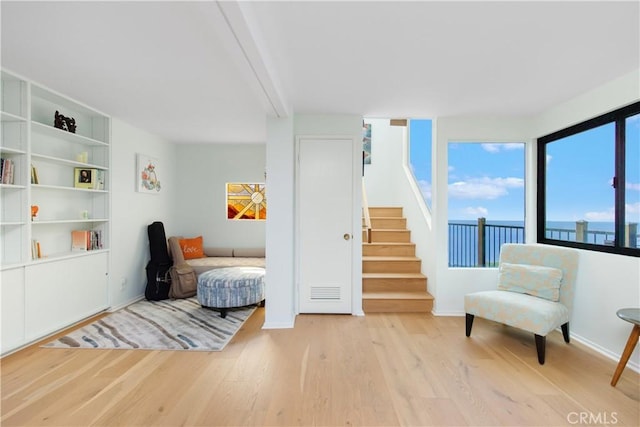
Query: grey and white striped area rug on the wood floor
xmin=43 ymin=297 xmax=256 ymax=351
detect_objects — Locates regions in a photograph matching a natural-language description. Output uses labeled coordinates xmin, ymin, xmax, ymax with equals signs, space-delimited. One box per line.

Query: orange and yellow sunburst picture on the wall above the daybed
xmin=226 ymin=182 xmax=267 ymax=221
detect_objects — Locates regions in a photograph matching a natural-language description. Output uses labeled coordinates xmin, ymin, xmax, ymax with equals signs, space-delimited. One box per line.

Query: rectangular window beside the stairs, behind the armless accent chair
xmin=448 ymin=142 xmax=525 ymax=267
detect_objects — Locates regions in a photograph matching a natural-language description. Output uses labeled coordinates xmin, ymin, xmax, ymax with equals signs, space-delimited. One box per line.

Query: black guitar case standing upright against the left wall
xmin=144 ymin=221 xmax=173 ymax=301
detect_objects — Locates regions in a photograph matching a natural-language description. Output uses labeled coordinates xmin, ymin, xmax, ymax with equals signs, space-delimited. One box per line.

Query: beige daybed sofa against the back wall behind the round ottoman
xmin=168 ymin=236 xmax=265 ymax=276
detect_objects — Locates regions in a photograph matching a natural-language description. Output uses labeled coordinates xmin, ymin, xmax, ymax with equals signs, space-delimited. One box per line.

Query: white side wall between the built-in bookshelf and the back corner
xmin=109 ymin=118 xmax=179 ymax=308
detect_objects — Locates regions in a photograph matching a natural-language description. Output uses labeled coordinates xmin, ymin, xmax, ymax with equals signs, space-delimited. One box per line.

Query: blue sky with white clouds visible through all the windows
xmin=410 ymin=116 xmax=640 ymax=226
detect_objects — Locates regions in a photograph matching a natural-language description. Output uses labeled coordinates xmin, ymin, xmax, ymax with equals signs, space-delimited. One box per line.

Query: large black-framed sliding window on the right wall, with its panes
xmin=537 ymin=102 xmax=640 ymax=256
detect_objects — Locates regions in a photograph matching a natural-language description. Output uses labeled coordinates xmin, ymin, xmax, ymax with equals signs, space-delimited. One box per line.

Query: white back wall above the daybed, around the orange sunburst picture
xmin=172 ymin=144 xmax=269 ymax=248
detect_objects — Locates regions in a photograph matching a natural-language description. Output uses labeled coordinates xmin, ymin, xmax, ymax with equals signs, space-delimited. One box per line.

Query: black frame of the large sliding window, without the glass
xmin=536 ymin=101 xmax=640 ymax=257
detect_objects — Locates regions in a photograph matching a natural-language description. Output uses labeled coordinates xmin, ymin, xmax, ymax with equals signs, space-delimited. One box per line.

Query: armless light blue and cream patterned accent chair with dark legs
xmin=464 ymin=243 xmax=578 ymax=365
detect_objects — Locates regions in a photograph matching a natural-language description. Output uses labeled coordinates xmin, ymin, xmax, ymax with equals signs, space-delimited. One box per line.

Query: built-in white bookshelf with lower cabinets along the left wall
xmin=0 ymin=70 xmax=111 ymax=354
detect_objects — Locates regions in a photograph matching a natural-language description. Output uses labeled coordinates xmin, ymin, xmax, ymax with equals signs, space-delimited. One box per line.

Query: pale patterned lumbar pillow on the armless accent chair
xmin=498 ymin=262 xmax=562 ymax=301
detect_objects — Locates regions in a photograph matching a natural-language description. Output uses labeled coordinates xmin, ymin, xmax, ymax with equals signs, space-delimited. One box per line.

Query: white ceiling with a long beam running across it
xmin=0 ymin=0 xmax=640 ymax=143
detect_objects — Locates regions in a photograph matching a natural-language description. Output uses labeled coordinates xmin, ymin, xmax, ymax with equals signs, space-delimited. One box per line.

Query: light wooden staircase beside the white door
xmin=362 ymin=207 xmax=433 ymax=313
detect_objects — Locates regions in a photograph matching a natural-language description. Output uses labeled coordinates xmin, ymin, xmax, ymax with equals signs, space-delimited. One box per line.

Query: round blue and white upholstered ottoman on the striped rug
xmin=197 ymin=267 xmax=264 ymax=318
